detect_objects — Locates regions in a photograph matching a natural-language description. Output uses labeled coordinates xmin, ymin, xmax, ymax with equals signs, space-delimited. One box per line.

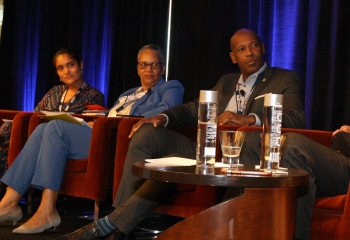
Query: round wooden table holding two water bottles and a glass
xmin=133 ymin=161 xmax=308 ymax=240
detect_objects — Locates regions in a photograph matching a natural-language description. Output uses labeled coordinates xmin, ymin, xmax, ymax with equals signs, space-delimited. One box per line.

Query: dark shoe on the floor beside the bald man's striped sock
xmin=54 ymin=222 xmax=104 ymax=240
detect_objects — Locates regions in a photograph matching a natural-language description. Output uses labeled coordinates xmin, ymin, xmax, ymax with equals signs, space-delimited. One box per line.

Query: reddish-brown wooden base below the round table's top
xmin=157 ymin=188 xmax=297 ymax=240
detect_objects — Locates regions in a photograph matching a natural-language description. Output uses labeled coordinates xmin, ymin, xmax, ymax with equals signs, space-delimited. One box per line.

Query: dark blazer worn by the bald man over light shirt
xmin=163 ymin=65 xmax=305 ymax=128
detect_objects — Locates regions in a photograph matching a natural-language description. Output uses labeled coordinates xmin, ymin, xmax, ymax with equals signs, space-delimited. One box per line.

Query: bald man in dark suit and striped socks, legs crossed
xmin=59 ymin=29 xmax=305 ymax=239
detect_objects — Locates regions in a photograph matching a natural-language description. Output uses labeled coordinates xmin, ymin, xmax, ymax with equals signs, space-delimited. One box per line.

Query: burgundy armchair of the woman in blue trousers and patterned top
xmin=8 ymin=113 xmax=126 ymax=219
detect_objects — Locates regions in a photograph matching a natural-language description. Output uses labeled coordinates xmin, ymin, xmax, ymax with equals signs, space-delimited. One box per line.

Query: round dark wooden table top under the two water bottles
xmin=133 ymin=161 xmax=309 ymax=188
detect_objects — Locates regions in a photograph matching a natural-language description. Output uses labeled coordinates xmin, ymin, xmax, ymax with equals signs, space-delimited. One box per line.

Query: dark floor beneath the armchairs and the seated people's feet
xmin=0 ymin=190 xmax=182 ymax=240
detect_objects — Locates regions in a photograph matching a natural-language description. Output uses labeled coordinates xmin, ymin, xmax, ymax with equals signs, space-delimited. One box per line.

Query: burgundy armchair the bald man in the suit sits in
xmin=113 ymin=118 xmax=238 ymax=218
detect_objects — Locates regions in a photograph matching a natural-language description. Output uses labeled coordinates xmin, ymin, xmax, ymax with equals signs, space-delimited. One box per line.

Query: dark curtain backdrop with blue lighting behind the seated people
xmin=0 ymin=0 xmax=350 ymax=130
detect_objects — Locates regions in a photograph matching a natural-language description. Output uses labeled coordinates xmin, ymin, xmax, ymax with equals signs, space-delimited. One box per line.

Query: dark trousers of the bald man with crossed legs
xmin=109 ymin=124 xmax=196 ymax=234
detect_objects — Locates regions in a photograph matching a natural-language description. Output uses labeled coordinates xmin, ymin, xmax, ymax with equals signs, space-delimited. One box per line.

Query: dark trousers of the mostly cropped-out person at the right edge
xmin=240 ymin=132 xmax=350 ymax=239
